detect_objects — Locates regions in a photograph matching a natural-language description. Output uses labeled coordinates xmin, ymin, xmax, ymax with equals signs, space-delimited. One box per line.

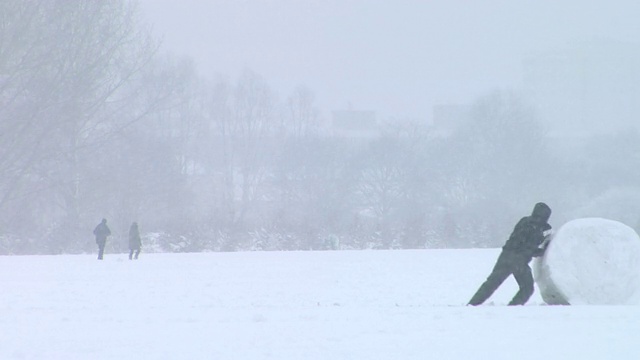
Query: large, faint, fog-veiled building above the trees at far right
xmin=523 ymin=42 xmax=640 ymax=138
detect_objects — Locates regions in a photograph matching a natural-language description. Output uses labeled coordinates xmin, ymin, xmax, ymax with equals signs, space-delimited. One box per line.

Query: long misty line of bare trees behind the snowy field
xmin=0 ymin=0 xmax=640 ymax=254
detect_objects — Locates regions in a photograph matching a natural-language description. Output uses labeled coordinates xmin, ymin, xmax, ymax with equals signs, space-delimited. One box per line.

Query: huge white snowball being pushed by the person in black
xmin=534 ymin=218 xmax=640 ymax=305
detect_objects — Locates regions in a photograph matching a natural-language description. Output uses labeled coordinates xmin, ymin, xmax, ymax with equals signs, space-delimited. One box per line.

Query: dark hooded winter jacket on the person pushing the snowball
xmin=502 ymin=203 xmax=551 ymax=263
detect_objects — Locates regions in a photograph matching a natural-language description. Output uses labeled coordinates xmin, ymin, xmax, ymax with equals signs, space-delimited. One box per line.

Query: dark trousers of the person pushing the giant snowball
xmin=469 ymin=251 xmax=533 ymax=305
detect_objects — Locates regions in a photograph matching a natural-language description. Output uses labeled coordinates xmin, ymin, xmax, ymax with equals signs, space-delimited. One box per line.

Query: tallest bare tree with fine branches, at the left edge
xmin=0 ymin=0 xmax=156 ymax=252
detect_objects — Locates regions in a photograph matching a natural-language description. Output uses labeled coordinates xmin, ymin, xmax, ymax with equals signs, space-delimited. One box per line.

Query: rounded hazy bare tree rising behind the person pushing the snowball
xmin=439 ymin=92 xmax=549 ymax=246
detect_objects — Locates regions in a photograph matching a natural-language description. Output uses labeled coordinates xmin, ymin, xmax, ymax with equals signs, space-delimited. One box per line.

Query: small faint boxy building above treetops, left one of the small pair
xmin=331 ymin=110 xmax=380 ymax=138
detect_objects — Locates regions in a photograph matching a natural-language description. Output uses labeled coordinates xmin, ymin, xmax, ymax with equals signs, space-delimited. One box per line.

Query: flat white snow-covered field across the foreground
xmin=0 ymin=250 xmax=640 ymax=360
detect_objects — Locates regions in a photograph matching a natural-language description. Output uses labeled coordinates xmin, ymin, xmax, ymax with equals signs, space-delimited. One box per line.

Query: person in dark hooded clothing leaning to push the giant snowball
xmin=469 ymin=203 xmax=551 ymax=305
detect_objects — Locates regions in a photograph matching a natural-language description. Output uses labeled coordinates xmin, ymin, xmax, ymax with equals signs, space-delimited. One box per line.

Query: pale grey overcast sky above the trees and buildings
xmin=140 ymin=0 xmax=640 ymax=119
